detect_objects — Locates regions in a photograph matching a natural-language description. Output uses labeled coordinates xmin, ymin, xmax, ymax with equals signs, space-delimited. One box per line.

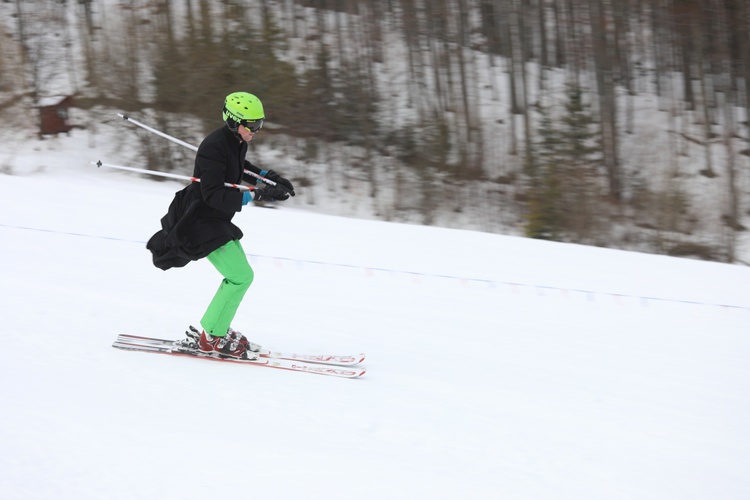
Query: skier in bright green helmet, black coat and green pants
xmin=146 ymin=92 xmax=295 ymax=359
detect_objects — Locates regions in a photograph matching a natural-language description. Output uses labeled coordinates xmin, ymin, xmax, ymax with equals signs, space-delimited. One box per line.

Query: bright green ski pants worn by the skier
xmin=201 ymin=240 xmax=255 ymax=337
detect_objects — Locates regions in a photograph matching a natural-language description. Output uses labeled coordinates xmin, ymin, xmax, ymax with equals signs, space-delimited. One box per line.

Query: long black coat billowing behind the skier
xmin=146 ymin=126 xmax=260 ymax=270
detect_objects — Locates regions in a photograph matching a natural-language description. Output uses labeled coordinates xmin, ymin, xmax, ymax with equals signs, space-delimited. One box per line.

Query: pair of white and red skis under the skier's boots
xmin=112 ymin=334 xmax=365 ymax=378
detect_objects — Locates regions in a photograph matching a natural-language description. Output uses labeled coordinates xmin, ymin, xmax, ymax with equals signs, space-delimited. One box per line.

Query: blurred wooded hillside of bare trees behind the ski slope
xmin=0 ymin=0 xmax=750 ymax=264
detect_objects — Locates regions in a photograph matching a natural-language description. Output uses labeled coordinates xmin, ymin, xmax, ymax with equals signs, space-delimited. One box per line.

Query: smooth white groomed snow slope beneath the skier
xmin=0 ymin=131 xmax=750 ymax=500
